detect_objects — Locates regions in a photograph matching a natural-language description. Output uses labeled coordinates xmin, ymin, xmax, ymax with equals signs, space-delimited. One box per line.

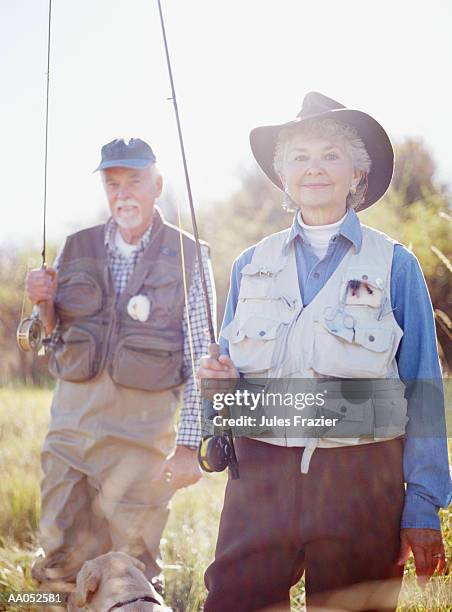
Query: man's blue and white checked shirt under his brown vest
xmin=48 ymin=218 xmax=216 ymax=448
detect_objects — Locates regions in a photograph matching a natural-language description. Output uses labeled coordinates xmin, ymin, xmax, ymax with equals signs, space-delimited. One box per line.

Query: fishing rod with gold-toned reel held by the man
xmin=16 ymin=0 xmax=52 ymax=353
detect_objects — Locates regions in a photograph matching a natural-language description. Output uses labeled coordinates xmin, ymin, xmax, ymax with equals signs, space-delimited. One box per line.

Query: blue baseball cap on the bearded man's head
xmin=94 ymin=138 xmax=157 ymax=172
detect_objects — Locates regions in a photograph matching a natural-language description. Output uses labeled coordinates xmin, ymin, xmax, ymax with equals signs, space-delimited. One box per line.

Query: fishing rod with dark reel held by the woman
xmin=157 ymin=0 xmax=239 ymax=479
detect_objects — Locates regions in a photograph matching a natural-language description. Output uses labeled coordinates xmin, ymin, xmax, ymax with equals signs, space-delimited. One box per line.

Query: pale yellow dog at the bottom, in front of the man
xmin=67 ymin=552 xmax=171 ymax=612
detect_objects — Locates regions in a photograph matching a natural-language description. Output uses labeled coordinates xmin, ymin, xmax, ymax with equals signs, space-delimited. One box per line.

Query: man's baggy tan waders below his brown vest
xmin=33 ymin=371 xmax=178 ymax=591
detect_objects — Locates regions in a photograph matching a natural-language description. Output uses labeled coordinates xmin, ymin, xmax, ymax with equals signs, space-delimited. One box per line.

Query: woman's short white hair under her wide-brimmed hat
xmin=273 ymin=119 xmax=372 ymax=210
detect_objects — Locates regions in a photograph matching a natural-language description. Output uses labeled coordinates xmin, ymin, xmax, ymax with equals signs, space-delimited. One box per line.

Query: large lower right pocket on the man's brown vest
xmin=111 ymin=335 xmax=183 ymax=391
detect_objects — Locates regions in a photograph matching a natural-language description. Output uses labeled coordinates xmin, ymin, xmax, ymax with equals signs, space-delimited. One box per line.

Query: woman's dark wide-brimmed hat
xmin=250 ymin=91 xmax=394 ymax=211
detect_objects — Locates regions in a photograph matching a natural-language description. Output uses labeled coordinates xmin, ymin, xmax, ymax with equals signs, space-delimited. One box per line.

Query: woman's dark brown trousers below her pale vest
xmin=204 ymin=438 xmax=404 ymax=612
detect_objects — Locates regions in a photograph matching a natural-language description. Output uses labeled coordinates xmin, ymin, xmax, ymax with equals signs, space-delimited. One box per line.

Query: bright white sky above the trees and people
xmin=0 ymin=0 xmax=452 ymax=250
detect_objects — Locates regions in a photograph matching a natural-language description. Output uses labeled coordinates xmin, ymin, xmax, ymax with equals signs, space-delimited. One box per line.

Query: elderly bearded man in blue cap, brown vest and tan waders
xmin=27 ymin=138 xmax=212 ymax=590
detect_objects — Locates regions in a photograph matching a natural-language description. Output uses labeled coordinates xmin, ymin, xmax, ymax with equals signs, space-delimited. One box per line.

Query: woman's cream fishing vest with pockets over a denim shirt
xmin=221 ymin=226 xmax=406 ymax=471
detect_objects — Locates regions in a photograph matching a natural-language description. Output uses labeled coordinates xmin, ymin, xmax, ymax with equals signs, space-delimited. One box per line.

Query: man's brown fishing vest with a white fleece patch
xmin=49 ymin=210 xmax=195 ymax=391
